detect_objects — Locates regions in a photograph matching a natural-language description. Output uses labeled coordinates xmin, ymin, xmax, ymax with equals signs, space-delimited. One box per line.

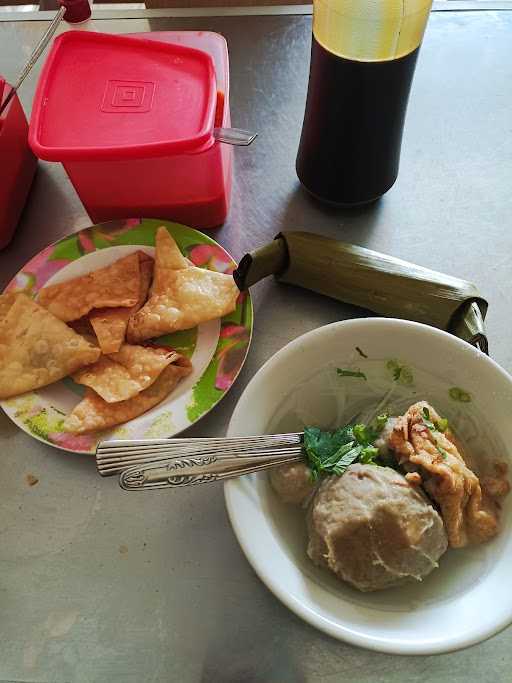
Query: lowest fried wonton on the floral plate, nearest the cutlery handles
xmin=64 ymin=357 xmax=192 ymax=434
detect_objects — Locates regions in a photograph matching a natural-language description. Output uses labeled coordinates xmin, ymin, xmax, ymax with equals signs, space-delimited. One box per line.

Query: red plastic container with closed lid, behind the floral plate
xmin=29 ymin=31 xmax=232 ymax=228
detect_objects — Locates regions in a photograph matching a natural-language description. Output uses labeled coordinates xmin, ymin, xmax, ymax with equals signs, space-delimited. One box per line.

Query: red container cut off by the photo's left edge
xmin=0 ymin=83 xmax=37 ymax=249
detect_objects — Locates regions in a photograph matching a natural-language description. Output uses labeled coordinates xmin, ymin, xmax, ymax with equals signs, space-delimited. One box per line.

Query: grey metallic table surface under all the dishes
xmin=0 ymin=6 xmax=512 ymax=683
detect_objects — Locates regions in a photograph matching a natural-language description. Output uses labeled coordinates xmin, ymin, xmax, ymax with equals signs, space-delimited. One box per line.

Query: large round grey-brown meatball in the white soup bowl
xmin=307 ymin=464 xmax=448 ymax=591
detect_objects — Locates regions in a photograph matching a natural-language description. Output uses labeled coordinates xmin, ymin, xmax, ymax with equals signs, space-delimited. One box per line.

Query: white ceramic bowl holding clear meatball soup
xmin=225 ymin=318 xmax=512 ymax=654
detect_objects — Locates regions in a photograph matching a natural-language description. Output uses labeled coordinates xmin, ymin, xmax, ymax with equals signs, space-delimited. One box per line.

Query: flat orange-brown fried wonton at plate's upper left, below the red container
xmin=38 ymin=253 xmax=140 ymax=322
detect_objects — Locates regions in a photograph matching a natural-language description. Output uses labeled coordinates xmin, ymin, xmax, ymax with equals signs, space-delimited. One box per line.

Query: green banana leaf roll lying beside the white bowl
xmin=234 ymin=231 xmax=488 ymax=353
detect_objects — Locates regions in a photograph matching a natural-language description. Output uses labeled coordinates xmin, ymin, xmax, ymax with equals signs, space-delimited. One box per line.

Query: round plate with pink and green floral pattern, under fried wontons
xmin=0 ymin=219 xmax=253 ymax=453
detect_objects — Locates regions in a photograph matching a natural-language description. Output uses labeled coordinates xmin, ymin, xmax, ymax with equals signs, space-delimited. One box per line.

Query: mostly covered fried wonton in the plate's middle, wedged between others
xmin=89 ymin=251 xmax=153 ymax=353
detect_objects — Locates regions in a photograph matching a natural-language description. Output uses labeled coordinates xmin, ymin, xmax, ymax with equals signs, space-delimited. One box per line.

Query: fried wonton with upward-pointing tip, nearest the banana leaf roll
xmin=127 ymin=226 xmax=239 ymax=343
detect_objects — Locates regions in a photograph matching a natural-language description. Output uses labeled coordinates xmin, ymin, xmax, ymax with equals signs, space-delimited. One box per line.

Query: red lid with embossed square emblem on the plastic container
xmin=29 ymin=31 xmax=216 ymax=161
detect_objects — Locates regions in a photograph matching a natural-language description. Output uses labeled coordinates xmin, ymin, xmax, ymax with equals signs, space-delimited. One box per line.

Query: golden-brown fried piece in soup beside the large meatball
xmin=389 ymin=401 xmax=498 ymax=548
